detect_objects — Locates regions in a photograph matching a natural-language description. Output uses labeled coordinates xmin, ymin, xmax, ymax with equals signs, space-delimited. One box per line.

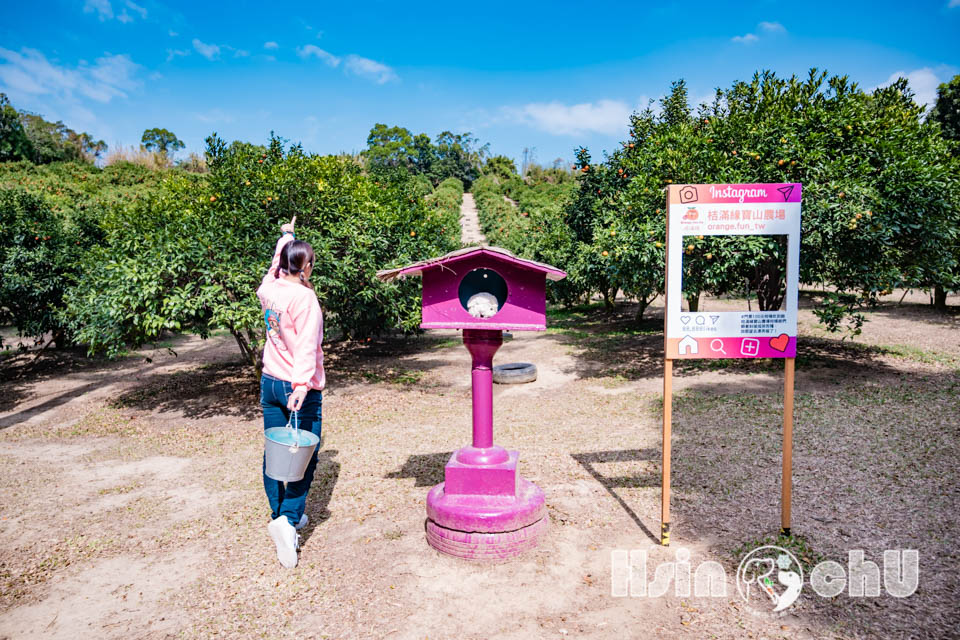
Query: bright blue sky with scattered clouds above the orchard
xmin=0 ymin=0 xmax=960 ymax=164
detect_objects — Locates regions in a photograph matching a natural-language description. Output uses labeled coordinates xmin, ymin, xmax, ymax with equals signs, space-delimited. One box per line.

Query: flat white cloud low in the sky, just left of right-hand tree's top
xmin=504 ymin=100 xmax=633 ymax=136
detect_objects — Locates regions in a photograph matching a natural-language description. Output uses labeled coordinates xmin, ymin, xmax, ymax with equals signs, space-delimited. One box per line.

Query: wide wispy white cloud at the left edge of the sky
xmin=0 ymin=47 xmax=140 ymax=104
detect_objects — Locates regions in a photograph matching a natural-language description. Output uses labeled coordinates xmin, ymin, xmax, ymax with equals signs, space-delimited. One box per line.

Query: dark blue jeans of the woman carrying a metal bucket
xmin=260 ymin=374 xmax=323 ymax=526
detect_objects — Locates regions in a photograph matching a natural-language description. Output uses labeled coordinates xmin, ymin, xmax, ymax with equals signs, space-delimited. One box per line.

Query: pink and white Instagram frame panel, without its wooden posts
xmin=665 ymin=183 xmax=802 ymax=359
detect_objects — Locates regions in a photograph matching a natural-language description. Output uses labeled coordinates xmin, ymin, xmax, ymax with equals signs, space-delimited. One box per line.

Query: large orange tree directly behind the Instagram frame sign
xmin=565 ymin=71 xmax=960 ymax=332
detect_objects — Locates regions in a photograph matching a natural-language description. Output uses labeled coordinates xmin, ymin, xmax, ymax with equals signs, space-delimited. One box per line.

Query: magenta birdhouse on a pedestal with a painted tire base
xmin=377 ymin=247 xmax=567 ymax=559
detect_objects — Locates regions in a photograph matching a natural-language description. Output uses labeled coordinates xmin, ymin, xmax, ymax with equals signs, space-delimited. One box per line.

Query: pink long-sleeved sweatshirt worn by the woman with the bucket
xmin=257 ymin=233 xmax=327 ymax=389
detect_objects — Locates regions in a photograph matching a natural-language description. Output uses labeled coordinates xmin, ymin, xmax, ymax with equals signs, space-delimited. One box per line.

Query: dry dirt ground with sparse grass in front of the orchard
xmin=0 ymin=286 xmax=960 ymax=639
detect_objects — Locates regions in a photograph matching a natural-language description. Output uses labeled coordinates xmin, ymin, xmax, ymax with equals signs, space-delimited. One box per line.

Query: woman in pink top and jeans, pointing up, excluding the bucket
xmin=257 ymin=216 xmax=326 ymax=568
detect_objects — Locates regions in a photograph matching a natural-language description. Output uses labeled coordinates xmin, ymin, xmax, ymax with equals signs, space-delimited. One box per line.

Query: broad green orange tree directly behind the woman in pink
xmin=64 ymin=134 xmax=457 ymax=366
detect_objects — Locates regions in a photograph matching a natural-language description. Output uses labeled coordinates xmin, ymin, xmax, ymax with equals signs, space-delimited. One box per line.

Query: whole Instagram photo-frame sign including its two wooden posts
xmin=660 ymin=183 xmax=802 ymax=546
